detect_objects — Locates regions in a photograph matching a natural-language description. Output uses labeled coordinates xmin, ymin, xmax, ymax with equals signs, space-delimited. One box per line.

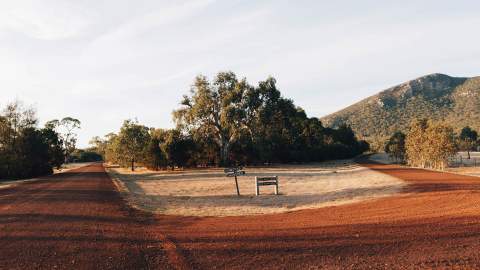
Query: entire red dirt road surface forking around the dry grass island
xmin=0 ymin=161 xmax=480 ymax=269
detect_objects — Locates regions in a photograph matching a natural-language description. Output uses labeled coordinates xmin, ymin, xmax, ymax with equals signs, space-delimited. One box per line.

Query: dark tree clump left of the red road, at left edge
xmin=0 ymin=101 xmax=80 ymax=179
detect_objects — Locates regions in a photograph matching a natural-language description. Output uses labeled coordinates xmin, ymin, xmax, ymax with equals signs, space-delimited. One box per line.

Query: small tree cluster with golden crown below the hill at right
xmin=385 ymin=119 xmax=479 ymax=169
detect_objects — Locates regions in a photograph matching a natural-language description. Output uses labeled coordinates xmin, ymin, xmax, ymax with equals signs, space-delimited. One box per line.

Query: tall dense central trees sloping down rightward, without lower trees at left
xmin=174 ymin=72 xmax=368 ymax=165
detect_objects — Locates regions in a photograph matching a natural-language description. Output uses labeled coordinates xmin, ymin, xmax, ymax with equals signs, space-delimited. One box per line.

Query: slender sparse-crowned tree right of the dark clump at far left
xmin=45 ymin=117 xmax=81 ymax=163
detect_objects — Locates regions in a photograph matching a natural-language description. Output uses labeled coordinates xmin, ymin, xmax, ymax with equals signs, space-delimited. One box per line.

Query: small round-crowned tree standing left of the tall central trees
xmin=116 ymin=120 xmax=150 ymax=171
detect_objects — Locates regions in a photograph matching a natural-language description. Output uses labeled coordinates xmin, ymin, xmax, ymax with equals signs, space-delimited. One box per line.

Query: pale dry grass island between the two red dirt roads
xmin=108 ymin=160 xmax=405 ymax=216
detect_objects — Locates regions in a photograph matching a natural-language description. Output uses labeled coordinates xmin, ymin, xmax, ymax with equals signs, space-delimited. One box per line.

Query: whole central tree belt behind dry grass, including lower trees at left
xmin=92 ymin=72 xmax=368 ymax=169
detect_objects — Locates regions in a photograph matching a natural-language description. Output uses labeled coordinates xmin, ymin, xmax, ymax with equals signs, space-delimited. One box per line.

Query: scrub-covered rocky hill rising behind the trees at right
xmin=321 ymin=73 xmax=480 ymax=138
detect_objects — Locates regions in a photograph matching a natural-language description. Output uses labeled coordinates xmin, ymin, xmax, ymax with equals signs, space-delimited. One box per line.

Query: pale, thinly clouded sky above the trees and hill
xmin=0 ymin=0 xmax=480 ymax=147
